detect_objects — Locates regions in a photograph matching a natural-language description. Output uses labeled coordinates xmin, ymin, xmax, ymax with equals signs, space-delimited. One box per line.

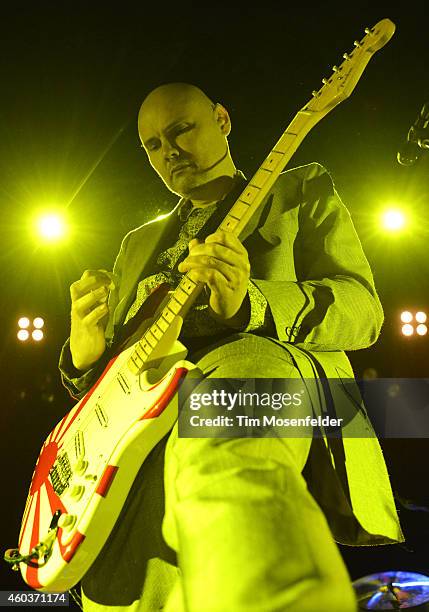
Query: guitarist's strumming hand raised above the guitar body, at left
xmin=70 ymin=270 xmax=113 ymax=371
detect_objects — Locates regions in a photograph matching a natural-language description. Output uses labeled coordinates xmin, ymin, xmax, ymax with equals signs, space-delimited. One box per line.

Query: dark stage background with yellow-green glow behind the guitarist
xmin=0 ymin=1 xmax=429 ymax=604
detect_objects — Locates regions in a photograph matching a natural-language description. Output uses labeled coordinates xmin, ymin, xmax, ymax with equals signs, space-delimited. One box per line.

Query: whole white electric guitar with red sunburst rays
xmin=5 ymin=19 xmax=395 ymax=591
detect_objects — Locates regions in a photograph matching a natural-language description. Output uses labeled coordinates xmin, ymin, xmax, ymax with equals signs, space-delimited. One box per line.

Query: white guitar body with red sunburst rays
xmin=19 ymin=342 xmax=195 ymax=591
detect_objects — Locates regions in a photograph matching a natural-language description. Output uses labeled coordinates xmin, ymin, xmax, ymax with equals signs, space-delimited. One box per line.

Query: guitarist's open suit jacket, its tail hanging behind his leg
xmin=60 ymin=163 xmax=403 ymax=544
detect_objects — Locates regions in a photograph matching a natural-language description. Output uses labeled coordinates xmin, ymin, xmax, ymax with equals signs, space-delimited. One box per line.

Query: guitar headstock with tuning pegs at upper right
xmin=303 ymin=19 xmax=395 ymax=116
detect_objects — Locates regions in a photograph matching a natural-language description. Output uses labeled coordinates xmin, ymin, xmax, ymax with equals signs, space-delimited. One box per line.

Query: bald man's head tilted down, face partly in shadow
xmin=139 ymin=90 xmax=229 ymax=197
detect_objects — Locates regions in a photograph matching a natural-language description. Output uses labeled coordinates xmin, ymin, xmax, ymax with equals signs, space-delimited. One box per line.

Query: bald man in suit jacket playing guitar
xmin=60 ymin=83 xmax=403 ymax=612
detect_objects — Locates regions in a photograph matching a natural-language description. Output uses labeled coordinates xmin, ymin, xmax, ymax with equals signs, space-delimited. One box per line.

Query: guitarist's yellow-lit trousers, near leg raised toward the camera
xmin=82 ymin=335 xmax=357 ymax=612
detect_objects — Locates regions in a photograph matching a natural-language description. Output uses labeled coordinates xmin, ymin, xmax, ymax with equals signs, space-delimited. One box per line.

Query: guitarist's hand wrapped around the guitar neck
xmin=178 ymin=230 xmax=250 ymax=326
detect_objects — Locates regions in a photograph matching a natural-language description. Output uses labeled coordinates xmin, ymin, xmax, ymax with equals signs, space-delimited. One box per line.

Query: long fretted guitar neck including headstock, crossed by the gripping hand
xmin=127 ymin=19 xmax=395 ymax=374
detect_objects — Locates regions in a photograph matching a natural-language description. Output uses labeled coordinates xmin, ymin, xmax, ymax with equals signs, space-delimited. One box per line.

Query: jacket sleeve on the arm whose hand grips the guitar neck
xmin=252 ymin=164 xmax=383 ymax=351
